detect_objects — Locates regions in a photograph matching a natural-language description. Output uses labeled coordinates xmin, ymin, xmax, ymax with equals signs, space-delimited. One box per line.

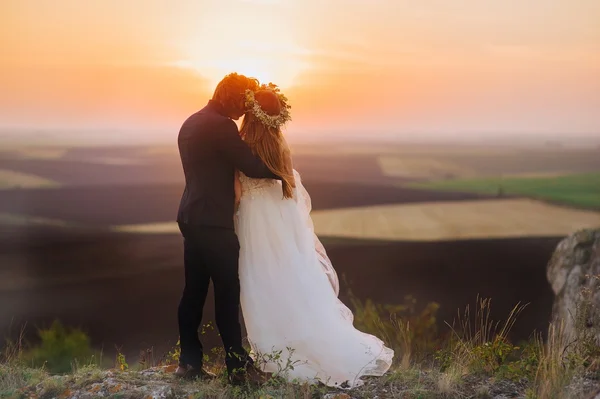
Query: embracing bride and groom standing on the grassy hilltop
xmin=176 ymin=73 xmax=394 ymax=388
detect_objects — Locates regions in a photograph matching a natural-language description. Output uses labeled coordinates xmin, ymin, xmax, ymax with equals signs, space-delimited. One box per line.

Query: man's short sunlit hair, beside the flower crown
xmin=213 ymin=72 xmax=259 ymax=115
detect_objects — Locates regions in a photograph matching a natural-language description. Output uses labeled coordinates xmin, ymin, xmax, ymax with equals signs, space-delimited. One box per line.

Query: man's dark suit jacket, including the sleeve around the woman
xmin=177 ymin=100 xmax=280 ymax=229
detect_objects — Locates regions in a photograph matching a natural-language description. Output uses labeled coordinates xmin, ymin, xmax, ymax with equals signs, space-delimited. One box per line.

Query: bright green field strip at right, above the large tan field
xmin=413 ymin=172 xmax=600 ymax=209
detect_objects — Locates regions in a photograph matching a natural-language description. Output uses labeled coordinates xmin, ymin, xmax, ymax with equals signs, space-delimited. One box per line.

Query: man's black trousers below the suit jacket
xmin=178 ymin=223 xmax=251 ymax=373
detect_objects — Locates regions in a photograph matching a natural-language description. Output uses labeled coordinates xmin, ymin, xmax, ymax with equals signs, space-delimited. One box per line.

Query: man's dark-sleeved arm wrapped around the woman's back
xmin=216 ymin=121 xmax=281 ymax=180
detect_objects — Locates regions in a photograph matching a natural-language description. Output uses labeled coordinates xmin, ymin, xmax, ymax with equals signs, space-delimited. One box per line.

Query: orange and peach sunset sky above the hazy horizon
xmin=0 ymin=0 xmax=600 ymax=140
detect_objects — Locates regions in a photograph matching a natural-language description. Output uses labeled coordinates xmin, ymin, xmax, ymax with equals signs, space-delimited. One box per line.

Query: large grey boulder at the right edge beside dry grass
xmin=546 ymin=228 xmax=600 ymax=343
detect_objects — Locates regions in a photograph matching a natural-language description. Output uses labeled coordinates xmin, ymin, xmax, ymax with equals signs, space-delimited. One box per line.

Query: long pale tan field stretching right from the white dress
xmin=312 ymin=199 xmax=600 ymax=241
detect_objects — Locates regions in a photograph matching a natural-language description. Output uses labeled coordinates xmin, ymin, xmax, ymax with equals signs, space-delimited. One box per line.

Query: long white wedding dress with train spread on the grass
xmin=236 ymin=171 xmax=394 ymax=388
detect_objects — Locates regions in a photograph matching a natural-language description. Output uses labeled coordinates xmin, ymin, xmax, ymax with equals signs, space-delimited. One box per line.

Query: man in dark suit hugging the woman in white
xmin=176 ymin=73 xmax=279 ymax=383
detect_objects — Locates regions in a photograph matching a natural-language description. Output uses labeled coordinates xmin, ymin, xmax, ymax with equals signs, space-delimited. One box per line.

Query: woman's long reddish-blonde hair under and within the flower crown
xmin=240 ymin=90 xmax=295 ymax=198
